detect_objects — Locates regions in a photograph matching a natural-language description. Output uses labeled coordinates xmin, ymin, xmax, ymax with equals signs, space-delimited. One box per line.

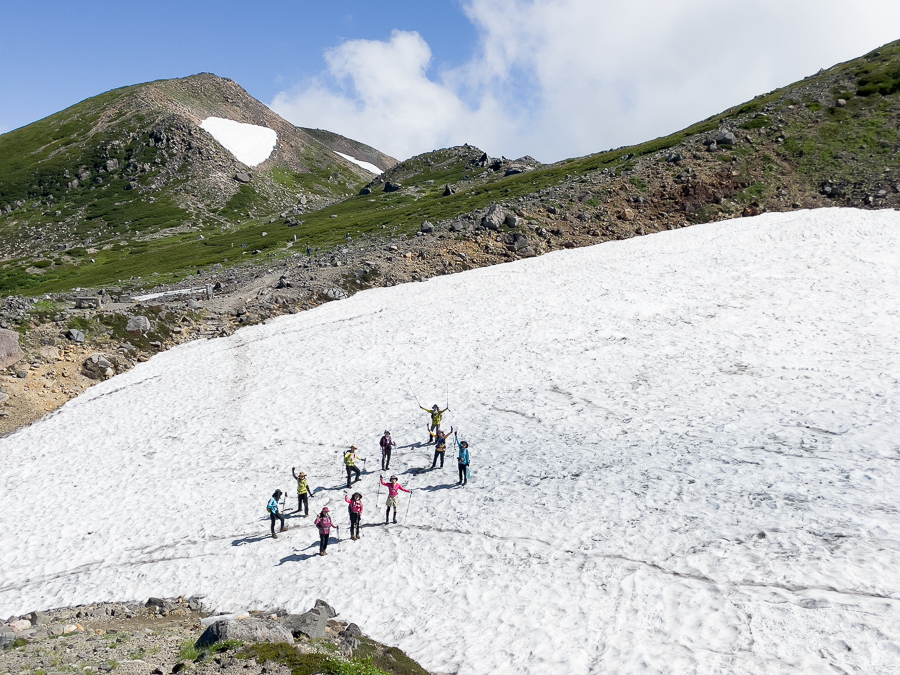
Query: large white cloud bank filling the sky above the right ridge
xmin=272 ymin=0 xmax=900 ymax=161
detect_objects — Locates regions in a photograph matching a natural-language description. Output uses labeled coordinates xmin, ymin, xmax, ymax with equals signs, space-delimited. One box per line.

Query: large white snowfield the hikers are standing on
xmin=0 ymin=209 xmax=900 ymax=675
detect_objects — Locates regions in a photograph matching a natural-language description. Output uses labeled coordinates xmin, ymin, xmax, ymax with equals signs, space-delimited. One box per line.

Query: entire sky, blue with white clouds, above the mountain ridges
xmin=0 ymin=0 xmax=900 ymax=161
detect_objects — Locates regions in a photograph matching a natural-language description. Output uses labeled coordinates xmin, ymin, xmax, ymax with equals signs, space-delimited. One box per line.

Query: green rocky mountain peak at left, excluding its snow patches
xmin=0 ymin=73 xmax=396 ymax=288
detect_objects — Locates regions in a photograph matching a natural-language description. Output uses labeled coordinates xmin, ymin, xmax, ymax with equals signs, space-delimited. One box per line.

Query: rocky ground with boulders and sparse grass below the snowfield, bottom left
xmin=0 ymin=598 xmax=428 ymax=675
